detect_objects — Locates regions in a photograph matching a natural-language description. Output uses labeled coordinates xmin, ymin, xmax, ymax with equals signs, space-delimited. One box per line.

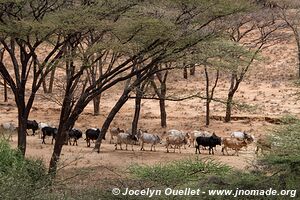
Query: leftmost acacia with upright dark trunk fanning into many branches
xmin=0 ymin=0 xmax=70 ymax=155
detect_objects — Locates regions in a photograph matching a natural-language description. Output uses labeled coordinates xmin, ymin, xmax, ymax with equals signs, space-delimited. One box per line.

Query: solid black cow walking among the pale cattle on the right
xmin=195 ymin=133 xmax=221 ymax=154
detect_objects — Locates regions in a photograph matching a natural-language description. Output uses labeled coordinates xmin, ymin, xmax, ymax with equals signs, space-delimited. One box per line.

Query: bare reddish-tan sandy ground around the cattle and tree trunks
xmin=0 ymin=29 xmax=300 ymax=175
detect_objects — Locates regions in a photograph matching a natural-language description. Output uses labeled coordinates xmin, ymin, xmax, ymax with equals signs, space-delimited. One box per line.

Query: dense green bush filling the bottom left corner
xmin=0 ymin=141 xmax=51 ymax=199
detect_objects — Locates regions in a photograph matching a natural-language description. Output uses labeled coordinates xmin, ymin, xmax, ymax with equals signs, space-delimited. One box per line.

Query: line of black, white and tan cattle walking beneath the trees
xmin=2 ymin=120 xmax=271 ymax=156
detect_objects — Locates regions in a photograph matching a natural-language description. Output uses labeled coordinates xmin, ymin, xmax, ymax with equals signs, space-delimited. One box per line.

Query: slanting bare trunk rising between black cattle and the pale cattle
xmin=94 ymin=89 xmax=131 ymax=153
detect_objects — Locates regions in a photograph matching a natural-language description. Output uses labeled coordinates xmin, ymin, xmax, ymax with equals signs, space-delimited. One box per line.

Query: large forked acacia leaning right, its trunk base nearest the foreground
xmin=49 ymin=2 xmax=169 ymax=175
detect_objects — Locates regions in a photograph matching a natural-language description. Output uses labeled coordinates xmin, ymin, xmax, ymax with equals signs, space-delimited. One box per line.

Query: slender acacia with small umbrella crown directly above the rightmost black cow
xmin=184 ymin=37 xmax=244 ymax=126
